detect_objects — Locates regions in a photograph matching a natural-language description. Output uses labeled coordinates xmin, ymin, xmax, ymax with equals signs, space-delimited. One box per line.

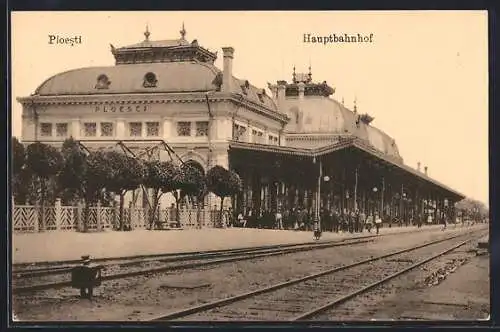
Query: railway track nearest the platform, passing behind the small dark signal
xmin=12 ymin=235 xmax=377 ymax=294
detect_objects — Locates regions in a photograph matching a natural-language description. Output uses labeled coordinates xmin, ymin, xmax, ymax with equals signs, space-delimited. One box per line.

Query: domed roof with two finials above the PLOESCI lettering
xmin=30 ymin=24 xmax=278 ymax=111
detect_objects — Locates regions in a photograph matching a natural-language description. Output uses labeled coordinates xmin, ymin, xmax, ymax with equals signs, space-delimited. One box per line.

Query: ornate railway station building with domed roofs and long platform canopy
xmin=18 ymin=27 xmax=464 ymax=221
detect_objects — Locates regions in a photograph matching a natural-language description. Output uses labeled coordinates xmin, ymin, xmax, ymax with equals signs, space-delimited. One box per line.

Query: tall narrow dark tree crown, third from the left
xmin=57 ymin=138 xmax=87 ymax=203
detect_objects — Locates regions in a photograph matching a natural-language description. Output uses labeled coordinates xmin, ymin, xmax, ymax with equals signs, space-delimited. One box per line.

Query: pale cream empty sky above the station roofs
xmin=11 ymin=11 xmax=489 ymax=205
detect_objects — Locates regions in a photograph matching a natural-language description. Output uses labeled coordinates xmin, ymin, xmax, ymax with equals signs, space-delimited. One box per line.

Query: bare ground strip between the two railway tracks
xmin=13 ymin=229 xmax=488 ymax=321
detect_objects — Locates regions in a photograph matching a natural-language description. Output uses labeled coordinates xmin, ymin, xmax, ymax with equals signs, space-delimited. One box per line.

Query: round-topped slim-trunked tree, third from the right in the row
xmin=144 ymin=160 xmax=179 ymax=229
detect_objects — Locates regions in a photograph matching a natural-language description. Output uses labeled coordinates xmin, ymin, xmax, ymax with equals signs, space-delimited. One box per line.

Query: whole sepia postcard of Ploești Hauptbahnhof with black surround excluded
xmin=9 ymin=11 xmax=490 ymax=325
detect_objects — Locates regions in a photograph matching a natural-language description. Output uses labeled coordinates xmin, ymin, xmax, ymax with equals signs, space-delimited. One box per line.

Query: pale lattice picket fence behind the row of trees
xmin=12 ymin=201 xmax=219 ymax=232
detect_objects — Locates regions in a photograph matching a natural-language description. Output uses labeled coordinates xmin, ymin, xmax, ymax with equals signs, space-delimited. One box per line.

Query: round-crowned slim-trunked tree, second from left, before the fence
xmin=26 ymin=142 xmax=63 ymax=229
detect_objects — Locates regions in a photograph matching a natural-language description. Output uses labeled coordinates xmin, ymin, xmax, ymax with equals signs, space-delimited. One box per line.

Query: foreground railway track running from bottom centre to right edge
xmin=152 ymin=230 xmax=484 ymax=321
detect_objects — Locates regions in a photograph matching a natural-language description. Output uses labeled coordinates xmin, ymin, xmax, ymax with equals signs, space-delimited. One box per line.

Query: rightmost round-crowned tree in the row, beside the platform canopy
xmin=207 ymin=165 xmax=242 ymax=226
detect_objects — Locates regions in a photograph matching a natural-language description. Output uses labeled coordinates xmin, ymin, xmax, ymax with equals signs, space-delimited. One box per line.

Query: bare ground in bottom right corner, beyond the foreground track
xmin=310 ymin=243 xmax=490 ymax=321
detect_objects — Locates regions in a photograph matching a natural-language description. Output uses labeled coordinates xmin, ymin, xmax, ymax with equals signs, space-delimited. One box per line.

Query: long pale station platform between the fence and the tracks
xmin=11 ymin=225 xmax=459 ymax=264
